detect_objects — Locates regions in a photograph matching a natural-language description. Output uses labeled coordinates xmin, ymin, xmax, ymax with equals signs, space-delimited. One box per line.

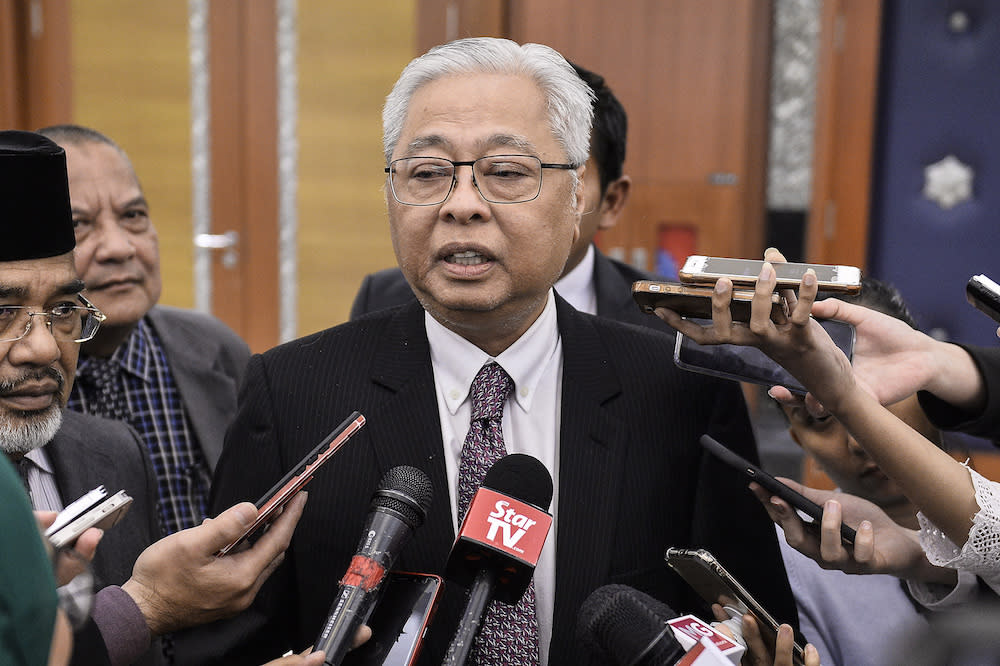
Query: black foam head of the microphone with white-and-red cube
xmin=576 ymin=585 xmax=685 ymax=666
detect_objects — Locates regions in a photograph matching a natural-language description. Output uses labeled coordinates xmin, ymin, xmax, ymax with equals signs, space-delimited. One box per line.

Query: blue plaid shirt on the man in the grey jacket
xmin=67 ymin=318 xmax=211 ymax=534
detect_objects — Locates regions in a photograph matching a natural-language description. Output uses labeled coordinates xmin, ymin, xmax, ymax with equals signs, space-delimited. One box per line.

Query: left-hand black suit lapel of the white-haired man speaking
xmin=366 ymin=302 xmax=455 ymax=571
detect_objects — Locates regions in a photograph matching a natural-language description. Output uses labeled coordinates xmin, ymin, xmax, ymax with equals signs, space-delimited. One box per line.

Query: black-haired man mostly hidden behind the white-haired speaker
xmin=351 ymin=65 xmax=673 ymax=334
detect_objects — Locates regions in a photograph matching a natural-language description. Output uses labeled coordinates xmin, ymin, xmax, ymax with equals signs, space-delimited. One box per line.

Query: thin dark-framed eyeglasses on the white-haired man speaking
xmin=385 ymin=155 xmax=578 ymax=206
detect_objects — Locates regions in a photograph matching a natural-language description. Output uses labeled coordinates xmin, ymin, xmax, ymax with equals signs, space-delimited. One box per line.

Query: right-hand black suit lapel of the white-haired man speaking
xmin=552 ymin=297 xmax=629 ymax=645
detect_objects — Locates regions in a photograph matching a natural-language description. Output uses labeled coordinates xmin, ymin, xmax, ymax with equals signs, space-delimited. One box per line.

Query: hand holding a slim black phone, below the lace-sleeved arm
xmin=750 ymin=479 xmax=955 ymax=584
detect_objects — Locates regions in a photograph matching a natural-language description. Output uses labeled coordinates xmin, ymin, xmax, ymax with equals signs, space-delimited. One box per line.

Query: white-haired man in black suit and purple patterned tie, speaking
xmin=197 ymin=38 xmax=795 ymax=664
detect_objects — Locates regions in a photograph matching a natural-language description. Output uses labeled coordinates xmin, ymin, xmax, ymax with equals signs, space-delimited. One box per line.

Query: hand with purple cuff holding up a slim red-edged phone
xmin=122 ymin=491 xmax=306 ymax=634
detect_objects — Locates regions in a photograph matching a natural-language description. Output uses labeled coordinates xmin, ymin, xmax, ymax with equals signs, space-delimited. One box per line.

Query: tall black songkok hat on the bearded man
xmin=0 ymin=130 xmax=76 ymax=261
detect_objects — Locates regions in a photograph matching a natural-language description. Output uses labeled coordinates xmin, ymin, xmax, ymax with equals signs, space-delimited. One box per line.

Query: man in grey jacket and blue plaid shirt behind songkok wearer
xmin=40 ymin=125 xmax=250 ymax=534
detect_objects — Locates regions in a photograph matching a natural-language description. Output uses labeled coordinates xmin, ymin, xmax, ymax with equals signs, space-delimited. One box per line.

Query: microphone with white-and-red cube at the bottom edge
xmin=576 ymin=585 xmax=746 ymax=666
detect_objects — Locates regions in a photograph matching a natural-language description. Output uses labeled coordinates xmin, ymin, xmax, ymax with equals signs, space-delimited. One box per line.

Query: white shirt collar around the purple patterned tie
xmin=424 ymin=289 xmax=559 ymax=414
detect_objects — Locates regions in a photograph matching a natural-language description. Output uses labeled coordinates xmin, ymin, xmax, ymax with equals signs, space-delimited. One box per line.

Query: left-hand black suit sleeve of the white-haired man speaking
xmin=174 ymin=356 xmax=296 ymax=665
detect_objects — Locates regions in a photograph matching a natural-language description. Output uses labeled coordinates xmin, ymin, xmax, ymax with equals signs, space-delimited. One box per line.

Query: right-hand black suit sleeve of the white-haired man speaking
xmin=693 ymin=380 xmax=798 ymax=631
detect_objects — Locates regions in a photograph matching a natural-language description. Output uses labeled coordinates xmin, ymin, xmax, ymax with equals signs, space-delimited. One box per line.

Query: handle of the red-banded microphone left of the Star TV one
xmin=313 ymin=510 xmax=413 ymax=666
